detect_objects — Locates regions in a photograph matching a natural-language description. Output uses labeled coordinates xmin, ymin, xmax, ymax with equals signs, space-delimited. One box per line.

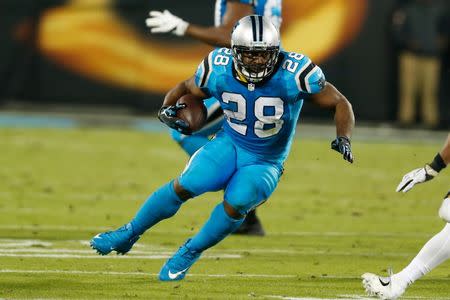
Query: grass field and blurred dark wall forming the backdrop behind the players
xmin=0 ymin=0 xmax=450 ymax=300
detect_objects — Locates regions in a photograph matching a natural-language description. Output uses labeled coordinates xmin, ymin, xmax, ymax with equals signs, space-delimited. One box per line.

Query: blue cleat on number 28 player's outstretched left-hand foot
xmin=91 ymin=223 xmax=140 ymax=255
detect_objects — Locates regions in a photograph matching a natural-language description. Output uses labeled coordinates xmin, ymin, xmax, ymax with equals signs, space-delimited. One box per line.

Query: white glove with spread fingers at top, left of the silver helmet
xmin=145 ymin=10 xmax=189 ymax=36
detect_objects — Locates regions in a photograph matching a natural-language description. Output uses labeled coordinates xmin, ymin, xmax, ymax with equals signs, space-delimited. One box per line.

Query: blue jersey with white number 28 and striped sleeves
xmin=195 ymin=48 xmax=325 ymax=160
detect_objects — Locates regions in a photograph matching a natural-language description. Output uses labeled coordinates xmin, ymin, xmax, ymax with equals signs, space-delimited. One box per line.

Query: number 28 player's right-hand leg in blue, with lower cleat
xmin=159 ymin=161 xmax=281 ymax=281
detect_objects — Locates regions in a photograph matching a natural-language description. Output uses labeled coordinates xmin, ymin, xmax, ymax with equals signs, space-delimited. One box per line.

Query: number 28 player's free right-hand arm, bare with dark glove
xmin=311 ymin=82 xmax=355 ymax=163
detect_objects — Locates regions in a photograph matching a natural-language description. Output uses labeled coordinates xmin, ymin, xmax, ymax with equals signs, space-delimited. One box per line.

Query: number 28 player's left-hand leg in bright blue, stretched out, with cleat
xmin=91 ymin=131 xmax=236 ymax=255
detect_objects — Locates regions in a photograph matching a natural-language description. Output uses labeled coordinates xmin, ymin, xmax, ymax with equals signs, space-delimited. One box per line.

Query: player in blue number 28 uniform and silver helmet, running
xmin=91 ymin=15 xmax=354 ymax=281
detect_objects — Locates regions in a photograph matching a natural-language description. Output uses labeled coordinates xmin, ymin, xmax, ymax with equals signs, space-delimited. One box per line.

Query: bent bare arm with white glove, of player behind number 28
xmin=146 ymin=0 xmax=253 ymax=48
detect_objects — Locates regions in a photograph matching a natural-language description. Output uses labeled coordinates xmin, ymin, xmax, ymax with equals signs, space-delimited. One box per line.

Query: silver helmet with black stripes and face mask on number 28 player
xmin=231 ymin=15 xmax=280 ymax=83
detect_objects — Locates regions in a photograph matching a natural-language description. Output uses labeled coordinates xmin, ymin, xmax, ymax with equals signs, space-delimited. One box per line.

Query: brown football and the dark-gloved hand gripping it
xmin=158 ymin=94 xmax=207 ymax=135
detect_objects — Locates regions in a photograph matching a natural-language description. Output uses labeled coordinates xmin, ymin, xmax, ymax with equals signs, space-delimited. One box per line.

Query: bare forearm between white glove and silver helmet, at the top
xmin=185 ymin=24 xmax=231 ymax=48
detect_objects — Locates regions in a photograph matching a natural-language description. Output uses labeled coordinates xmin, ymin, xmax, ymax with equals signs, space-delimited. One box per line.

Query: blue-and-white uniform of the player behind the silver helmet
xmin=214 ymin=0 xmax=281 ymax=28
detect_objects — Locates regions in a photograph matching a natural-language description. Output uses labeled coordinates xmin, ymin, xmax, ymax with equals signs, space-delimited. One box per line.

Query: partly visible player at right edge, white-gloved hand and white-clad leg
xmin=362 ymin=134 xmax=450 ymax=299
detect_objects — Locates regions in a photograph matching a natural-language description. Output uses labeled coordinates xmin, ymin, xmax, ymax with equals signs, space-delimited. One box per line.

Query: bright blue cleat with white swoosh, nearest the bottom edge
xmin=159 ymin=239 xmax=202 ymax=281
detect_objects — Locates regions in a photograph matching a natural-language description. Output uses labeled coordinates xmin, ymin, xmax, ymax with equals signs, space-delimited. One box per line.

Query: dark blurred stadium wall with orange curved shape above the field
xmin=0 ymin=0 xmax=450 ymax=130
